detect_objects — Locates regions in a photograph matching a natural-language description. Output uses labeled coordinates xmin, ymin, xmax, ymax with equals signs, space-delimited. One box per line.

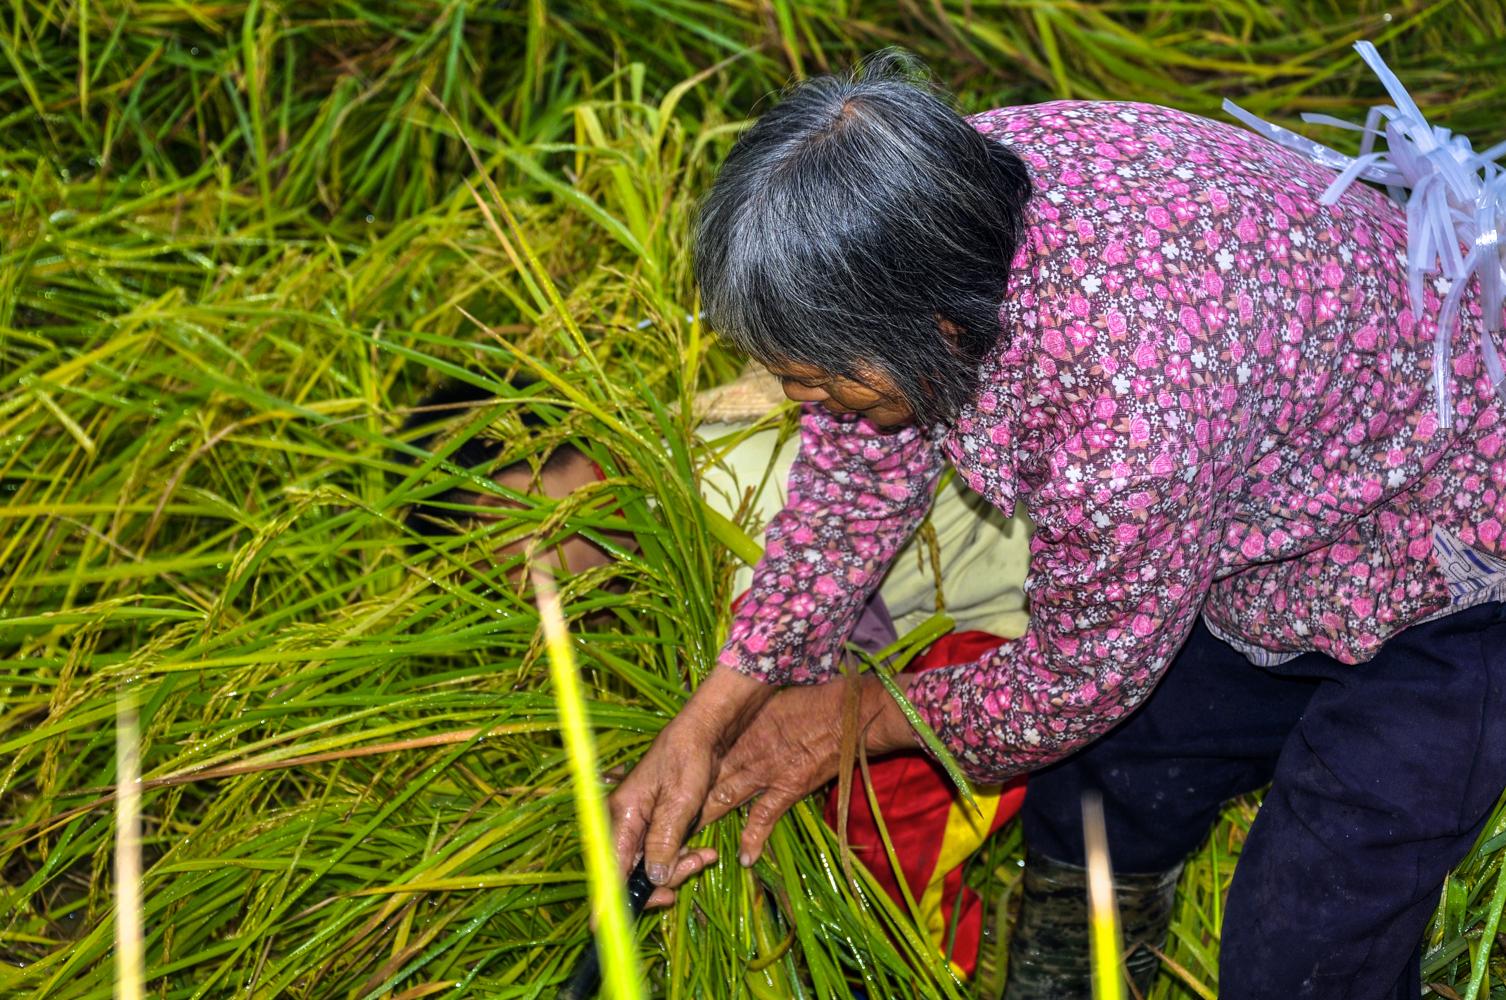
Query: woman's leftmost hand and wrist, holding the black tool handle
xmin=607 ymin=667 xmax=774 ymax=905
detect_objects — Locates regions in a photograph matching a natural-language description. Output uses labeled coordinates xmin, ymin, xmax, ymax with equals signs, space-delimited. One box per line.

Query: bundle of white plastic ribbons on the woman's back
xmin=1223 ymin=42 xmax=1506 ymax=429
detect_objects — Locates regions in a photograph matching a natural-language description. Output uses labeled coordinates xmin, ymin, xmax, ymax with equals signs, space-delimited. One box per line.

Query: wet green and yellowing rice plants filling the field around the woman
xmin=0 ymin=0 xmax=1506 ymax=998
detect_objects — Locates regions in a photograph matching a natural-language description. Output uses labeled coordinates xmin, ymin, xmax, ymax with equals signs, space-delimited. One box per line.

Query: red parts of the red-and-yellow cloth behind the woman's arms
xmin=825 ymin=631 xmax=1024 ymax=976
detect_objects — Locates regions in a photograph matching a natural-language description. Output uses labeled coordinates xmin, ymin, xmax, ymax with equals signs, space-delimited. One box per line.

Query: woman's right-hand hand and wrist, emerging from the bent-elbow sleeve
xmin=702 ymin=675 xmax=919 ymax=866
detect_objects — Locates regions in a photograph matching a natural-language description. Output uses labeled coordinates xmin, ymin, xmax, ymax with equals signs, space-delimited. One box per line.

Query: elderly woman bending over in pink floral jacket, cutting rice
xmin=611 ymin=54 xmax=1506 ymax=1000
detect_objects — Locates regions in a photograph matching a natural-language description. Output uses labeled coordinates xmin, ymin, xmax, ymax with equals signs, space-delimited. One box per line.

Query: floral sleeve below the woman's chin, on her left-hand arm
xmin=718 ymin=405 xmax=943 ymax=684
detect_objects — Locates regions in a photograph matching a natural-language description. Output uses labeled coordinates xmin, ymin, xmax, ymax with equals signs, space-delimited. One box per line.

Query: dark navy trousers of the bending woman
xmin=1023 ymin=604 xmax=1506 ymax=1000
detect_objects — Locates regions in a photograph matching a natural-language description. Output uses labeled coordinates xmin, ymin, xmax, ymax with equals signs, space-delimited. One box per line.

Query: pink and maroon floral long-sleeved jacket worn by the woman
xmin=720 ymin=102 xmax=1506 ymax=780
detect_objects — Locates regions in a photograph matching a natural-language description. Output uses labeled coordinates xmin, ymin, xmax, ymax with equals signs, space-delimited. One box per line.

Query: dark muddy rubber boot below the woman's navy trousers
xmin=1005 ymin=854 xmax=1182 ymax=1000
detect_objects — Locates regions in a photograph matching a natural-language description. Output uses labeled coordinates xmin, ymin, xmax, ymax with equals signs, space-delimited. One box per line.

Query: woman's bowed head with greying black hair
xmin=696 ymin=53 xmax=1030 ymax=423
